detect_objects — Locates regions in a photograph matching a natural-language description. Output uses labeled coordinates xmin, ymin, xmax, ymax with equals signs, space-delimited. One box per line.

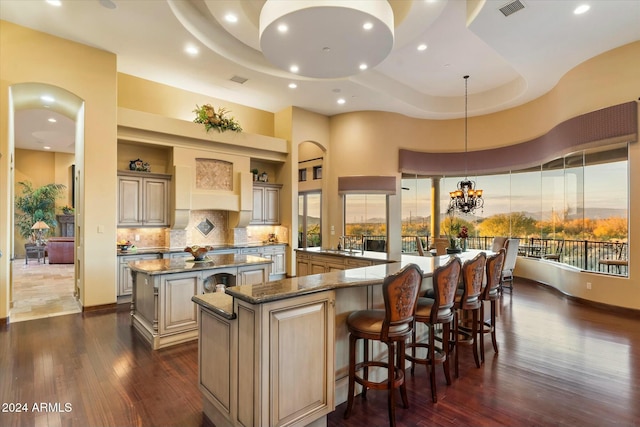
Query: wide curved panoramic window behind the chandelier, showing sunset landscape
xmin=432 ymin=144 xmax=629 ymax=275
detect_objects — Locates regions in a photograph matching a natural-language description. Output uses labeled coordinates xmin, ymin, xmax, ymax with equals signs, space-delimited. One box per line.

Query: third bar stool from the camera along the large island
xmin=453 ymin=252 xmax=487 ymax=378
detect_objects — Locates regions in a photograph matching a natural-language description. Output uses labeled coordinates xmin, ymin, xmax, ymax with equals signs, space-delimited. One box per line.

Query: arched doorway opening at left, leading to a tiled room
xmin=8 ymin=83 xmax=84 ymax=322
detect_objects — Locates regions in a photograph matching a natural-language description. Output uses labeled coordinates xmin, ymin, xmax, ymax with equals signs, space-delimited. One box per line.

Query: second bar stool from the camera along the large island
xmin=406 ymin=256 xmax=462 ymax=403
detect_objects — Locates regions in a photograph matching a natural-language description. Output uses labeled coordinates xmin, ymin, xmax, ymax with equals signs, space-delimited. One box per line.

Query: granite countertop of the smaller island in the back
xmin=129 ymin=254 xmax=273 ymax=276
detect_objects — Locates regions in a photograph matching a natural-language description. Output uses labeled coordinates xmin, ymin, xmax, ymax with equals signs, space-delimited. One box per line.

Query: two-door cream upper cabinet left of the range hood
xmin=118 ymin=171 xmax=171 ymax=227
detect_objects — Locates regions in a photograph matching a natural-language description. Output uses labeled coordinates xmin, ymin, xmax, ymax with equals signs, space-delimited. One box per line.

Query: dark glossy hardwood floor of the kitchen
xmin=0 ymin=280 xmax=640 ymax=427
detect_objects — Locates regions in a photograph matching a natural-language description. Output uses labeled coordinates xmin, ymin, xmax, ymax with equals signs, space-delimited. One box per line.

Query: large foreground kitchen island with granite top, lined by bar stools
xmin=193 ymin=251 xmax=484 ymax=427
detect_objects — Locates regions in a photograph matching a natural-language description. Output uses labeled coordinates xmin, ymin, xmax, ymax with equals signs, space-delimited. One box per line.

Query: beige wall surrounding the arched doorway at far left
xmin=0 ymin=21 xmax=117 ymax=319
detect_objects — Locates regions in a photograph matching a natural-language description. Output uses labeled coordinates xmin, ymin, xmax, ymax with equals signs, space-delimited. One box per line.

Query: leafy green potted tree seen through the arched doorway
xmin=15 ymin=181 xmax=67 ymax=240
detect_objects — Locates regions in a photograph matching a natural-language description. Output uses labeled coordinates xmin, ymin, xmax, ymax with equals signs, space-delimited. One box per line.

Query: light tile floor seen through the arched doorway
xmin=9 ymin=259 xmax=82 ymax=323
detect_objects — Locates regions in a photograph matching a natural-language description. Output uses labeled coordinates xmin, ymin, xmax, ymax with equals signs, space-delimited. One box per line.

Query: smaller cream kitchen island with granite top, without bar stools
xmin=128 ymin=254 xmax=272 ymax=350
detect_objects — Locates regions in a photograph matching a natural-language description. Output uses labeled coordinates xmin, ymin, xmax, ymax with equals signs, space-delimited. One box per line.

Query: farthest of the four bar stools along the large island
xmin=480 ymin=248 xmax=506 ymax=363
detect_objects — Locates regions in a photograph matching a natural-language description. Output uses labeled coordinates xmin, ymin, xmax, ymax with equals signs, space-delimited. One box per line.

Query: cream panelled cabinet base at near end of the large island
xmin=198 ymin=291 xmax=335 ymax=427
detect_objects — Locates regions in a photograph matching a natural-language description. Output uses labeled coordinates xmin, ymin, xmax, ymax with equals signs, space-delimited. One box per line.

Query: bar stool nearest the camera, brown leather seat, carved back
xmin=344 ymin=264 xmax=422 ymax=426
